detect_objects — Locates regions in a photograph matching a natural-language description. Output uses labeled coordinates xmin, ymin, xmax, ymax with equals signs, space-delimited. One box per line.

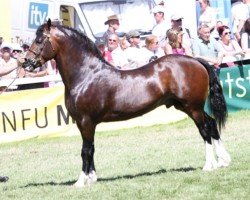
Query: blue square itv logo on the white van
xmin=28 ymin=2 xmax=49 ymax=29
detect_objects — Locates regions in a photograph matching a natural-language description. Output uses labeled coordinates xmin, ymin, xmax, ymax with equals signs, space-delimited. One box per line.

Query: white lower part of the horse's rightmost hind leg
xmin=214 ymin=139 xmax=231 ymax=167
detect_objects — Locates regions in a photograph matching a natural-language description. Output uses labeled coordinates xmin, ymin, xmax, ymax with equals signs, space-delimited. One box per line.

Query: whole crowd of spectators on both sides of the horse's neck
xmin=0 ymin=0 xmax=250 ymax=89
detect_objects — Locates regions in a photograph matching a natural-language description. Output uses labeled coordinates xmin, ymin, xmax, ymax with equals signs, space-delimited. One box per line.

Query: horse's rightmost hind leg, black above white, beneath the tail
xmin=206 ymin=114 xmax=231 ymax=167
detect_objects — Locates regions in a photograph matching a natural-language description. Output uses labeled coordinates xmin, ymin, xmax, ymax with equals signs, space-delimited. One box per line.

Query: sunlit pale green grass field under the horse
xmin=0 ymin=111 xmax=250 ymax=200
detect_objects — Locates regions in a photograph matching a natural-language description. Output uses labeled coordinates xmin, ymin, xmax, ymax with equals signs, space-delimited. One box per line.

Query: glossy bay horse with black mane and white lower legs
xmin=23 ymin=20 xmax=231 ymax=187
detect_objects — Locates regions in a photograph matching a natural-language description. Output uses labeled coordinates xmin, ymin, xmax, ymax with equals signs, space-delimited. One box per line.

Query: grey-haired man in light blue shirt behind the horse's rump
xmin=192 ymin=24 xmax=224 ymax=68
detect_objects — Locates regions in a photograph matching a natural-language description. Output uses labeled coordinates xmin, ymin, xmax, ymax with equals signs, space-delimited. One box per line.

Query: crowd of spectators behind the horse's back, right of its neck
xmin=96 ymin=0 xmax=250 ymax=69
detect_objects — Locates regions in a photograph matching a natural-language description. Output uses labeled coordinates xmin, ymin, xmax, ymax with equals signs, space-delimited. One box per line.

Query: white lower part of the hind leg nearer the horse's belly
xmin=203 ymin=141 xmax=217 ymax=171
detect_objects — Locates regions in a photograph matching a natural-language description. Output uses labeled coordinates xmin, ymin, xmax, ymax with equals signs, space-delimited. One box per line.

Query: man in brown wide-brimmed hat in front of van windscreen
xmin=102 ymin=15 xmax=120 ymax=46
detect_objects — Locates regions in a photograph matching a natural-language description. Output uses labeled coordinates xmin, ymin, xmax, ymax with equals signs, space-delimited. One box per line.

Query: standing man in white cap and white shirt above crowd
xmin=152 ymin=5 xmax=171 ymax=47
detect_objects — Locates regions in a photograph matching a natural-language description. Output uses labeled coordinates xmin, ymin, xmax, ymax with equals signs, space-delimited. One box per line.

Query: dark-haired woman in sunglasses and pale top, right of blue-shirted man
xmin=218 ymin=25 xmax=245 ymax=66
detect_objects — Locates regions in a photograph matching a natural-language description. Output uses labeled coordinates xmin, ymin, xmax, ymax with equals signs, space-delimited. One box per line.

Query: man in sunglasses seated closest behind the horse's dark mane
xmin=104 ymin=34 xmax=128 ymax=69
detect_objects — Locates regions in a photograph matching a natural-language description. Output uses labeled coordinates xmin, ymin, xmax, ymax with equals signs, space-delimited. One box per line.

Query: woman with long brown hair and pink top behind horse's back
xmin=164 ymin=29 xmax=192 ymax=56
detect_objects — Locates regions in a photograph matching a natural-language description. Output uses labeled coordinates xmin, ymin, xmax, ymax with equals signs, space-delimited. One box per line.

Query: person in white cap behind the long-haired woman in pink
xmin=171 ymin=14 xmax=193 ymax=48
